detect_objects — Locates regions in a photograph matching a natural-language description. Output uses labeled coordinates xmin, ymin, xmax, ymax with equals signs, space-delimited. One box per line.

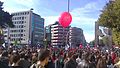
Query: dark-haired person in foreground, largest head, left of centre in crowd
xmin=30 ymin=49 xmax=50 ymax=68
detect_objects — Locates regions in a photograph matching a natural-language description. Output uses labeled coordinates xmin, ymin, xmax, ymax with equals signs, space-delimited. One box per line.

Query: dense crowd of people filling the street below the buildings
xmin=0 ymin=46 xmax=120 ymax=68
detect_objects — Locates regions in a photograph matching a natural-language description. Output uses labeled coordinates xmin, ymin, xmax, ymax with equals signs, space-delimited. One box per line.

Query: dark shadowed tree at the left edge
xmin=0 ymin=1 xmax=14 ymax=44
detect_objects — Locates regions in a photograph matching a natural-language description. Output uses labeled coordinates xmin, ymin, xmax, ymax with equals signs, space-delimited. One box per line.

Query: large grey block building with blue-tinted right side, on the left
xmin=4 ymin=10 xmax=44 ymax=45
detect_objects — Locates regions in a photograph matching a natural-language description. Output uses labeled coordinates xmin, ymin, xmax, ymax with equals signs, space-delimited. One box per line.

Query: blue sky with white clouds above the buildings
xmin=0 ymin=0 xmax=108 ymax=42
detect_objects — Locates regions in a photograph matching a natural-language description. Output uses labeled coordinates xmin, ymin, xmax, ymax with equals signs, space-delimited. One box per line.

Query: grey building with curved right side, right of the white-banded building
xmin=68 ymin=27 xmax=86 ymax=47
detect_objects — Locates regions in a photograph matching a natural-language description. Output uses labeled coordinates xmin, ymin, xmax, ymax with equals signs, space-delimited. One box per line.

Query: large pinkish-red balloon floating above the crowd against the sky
xmin=59 ymin=12 xmax=72 ymax=28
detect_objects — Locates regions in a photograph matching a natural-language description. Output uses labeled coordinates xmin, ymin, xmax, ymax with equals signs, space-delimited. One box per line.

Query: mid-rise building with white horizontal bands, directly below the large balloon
xmin=50 ymin=22 xmax=69 ymax=47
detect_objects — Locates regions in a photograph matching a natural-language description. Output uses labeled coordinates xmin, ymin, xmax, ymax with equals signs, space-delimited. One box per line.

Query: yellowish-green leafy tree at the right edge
xmin=97 ymin=0 xmax=120 ymax=45
